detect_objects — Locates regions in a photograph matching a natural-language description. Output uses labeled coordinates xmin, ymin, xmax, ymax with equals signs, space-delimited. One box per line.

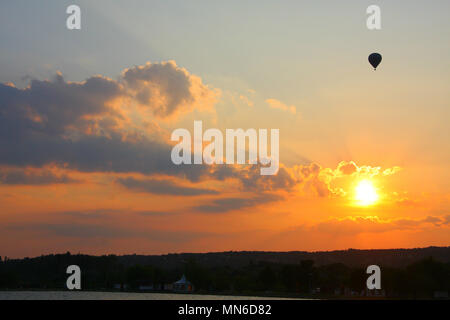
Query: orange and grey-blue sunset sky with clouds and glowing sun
xmin=0 ymin=0 xmax=450 ymax=257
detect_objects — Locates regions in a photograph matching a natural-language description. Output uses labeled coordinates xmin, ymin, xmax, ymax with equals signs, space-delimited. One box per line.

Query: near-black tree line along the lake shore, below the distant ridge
xmin=0 ymin=252 xmax=450 ymax=298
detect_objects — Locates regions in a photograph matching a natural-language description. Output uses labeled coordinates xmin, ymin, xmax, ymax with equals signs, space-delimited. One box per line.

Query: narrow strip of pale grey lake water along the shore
xmin=0 ymin=291 xmax=296 ymax=300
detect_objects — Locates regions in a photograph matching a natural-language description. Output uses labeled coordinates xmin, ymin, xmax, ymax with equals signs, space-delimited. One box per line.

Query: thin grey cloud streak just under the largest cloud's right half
xmin=116 ymin=177 xmax=218 ymax=196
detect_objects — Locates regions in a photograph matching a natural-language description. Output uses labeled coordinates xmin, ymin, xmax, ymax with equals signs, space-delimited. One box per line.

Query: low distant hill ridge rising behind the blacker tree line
xmin=4 ymin=246 xmax=450 ymax=267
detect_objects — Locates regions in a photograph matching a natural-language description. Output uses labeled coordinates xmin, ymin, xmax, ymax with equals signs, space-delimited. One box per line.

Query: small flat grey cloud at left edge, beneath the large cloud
xmin=0 ymin=168 xmax=77 ymax=185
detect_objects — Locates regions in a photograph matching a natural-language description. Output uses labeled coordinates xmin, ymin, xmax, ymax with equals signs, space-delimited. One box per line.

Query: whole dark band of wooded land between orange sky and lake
xmin=0 ymin=247 xmax=450 ymax=299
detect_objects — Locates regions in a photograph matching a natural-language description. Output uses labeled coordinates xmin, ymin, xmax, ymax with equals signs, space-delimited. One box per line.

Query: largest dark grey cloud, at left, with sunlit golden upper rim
xmin=0 ymin=63 xmax=216 ymax=181
